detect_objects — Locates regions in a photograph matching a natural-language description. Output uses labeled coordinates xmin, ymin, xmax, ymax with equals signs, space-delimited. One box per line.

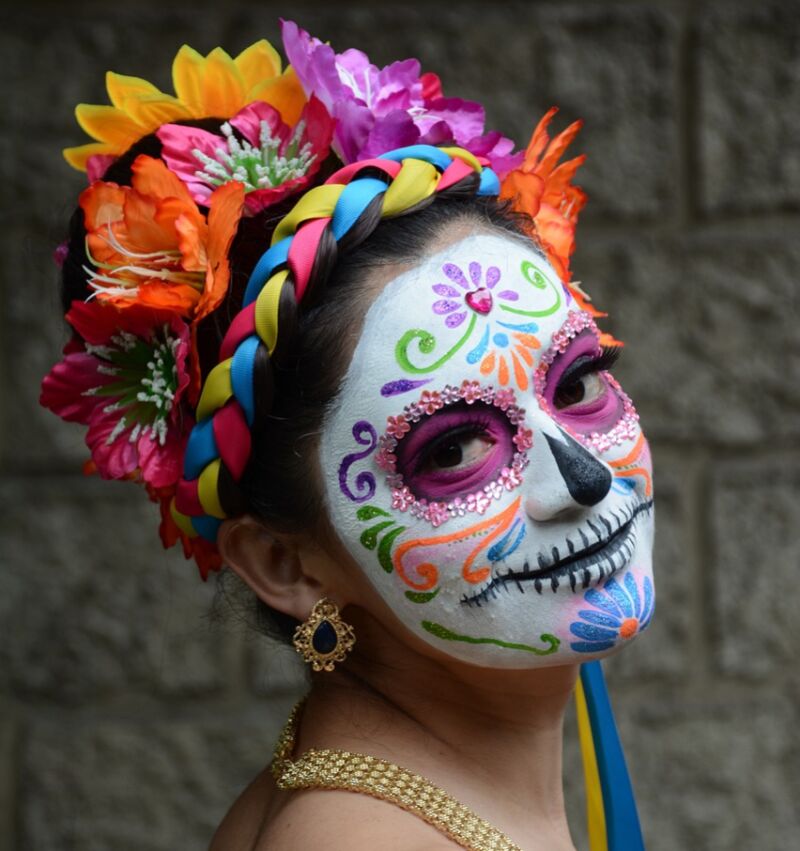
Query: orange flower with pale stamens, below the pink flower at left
xmin=80 ymin=155 xmax=244 ymax=321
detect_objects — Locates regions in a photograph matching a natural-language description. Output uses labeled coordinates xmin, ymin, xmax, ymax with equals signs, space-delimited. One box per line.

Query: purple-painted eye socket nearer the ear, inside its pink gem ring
xmin=395 ymin=402 xmax=515 ymax=500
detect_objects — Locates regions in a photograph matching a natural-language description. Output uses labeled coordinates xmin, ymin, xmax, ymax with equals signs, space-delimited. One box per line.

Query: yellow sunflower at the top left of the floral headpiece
xmin=64 ymin=39 xmax=306 ymax=171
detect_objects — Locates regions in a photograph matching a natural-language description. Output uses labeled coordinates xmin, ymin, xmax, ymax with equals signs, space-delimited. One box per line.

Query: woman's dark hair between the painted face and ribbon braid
xmin=62 ymin=128 xmax=531 ymax=641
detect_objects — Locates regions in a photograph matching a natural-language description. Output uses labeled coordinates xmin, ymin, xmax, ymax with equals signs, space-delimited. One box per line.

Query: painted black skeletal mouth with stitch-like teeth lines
xmin=461 ymin=499 xmax=653 ymax=606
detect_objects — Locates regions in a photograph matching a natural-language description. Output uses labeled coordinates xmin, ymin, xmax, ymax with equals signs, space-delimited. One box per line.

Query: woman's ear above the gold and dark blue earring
xmin=217 ymin=514 xmax=328 ymax=621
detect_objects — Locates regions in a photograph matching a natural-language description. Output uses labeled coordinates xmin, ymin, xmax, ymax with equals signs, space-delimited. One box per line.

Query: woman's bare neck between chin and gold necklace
xmin=301 ymin=618 xmax=578 ymax=849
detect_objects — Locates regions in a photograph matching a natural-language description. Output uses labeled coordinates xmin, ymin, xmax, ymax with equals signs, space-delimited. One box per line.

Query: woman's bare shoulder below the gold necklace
xmin=253 ymin=790 xmax=458 ymax=851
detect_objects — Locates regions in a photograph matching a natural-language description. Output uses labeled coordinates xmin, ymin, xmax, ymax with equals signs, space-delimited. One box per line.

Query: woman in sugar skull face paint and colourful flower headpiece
xmin=43 ymin=23 xmax=653 ymax=851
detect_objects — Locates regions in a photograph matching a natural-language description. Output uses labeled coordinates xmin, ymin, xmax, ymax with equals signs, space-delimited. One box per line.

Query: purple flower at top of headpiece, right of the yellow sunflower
xmin=281 ymin=20 xmax=524 ymax=179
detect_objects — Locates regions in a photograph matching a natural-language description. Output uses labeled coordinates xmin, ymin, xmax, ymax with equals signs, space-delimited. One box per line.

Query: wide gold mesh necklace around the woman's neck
xmin=272 ymin=700 xmax=522 ymax=851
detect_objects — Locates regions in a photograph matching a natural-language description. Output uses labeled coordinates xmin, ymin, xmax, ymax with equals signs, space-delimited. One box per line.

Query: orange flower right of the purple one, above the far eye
xmin=500 ymin=107 xmax=588 ymax=286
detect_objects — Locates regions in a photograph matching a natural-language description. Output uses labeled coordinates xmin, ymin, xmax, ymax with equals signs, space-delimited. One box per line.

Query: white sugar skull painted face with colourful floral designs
xmin=320 ymin=234 xmax=654 ymax=668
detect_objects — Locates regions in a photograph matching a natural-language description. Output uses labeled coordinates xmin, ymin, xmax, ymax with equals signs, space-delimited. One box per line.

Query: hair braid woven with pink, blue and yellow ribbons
xmin=173 ymin=145 xmax=520 ymax=540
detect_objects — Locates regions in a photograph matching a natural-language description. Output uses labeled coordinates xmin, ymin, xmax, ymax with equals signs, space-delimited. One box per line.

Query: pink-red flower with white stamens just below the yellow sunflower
xmin=156 ymin=97 xmax=334 ymax=215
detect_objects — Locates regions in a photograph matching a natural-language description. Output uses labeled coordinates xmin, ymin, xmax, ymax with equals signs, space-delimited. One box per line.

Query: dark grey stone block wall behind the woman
xmin=0 ymin=0 xmax=800 ymax=851
